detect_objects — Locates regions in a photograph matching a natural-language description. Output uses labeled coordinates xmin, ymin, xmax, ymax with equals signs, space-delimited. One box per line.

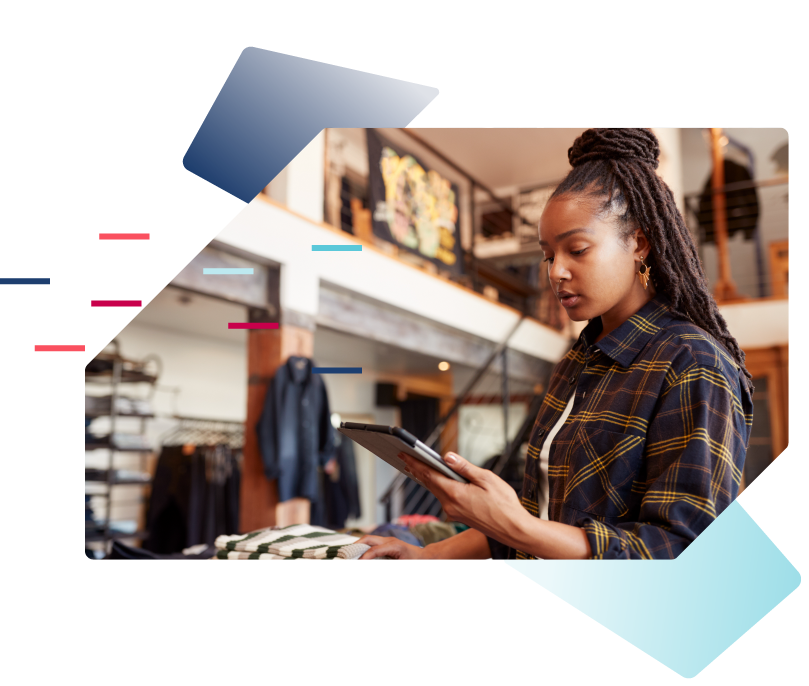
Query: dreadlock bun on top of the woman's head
xmin=567 ymin=128 xmax=660 ymax=169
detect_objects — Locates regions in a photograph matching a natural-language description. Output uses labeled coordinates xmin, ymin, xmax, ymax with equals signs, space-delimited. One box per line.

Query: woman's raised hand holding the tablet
xmin=399 ymin=453 xmax=531 ymax=544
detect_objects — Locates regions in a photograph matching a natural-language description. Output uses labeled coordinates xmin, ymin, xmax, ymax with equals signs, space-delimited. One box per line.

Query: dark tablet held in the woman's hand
xmin=337 ymin=422 xmax=469 ymax=488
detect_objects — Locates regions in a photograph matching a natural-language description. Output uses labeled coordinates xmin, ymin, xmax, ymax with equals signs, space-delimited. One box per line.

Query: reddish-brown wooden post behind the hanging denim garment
xmin=239 ymin=326 xmax=314 ymax=533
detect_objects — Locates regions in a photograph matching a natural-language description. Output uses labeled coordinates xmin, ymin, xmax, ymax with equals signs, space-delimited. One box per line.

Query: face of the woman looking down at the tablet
xmin=539 ymin=196 xmax=654 ymax=331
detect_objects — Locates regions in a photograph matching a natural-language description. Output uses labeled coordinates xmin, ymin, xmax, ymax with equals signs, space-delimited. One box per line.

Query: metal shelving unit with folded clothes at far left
xmin=84 ymin=341 xmax=160 ymax=552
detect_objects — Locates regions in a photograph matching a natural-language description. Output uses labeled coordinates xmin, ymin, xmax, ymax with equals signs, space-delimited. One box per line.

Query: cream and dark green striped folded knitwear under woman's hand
xmin=214 ymin=524 xmax=370 ymax=560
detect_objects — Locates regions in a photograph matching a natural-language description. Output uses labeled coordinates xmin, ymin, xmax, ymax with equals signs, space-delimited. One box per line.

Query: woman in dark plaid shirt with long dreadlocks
xmin=360 ymin=128 xmax=753 ymax=560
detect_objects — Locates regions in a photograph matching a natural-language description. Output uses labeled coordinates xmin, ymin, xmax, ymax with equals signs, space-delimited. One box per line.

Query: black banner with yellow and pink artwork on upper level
xmin=369 ymin=131 xmax=460 ymax=271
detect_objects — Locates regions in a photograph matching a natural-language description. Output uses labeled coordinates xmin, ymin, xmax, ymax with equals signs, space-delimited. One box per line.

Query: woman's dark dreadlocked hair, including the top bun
xmin=551 ymin=128 xmax=753 ymax=389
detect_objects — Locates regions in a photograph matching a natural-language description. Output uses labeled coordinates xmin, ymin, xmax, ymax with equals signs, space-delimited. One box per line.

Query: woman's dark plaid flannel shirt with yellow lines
xmin=508 ymin=293 xmax=753 ymax=560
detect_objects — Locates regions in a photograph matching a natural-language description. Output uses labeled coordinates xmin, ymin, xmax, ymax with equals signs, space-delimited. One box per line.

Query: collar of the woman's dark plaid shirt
xmin=581 ymin=292 xmax=672 ymax=367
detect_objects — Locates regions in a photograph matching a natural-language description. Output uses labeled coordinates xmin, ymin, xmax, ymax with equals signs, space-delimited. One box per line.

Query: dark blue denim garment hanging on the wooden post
xmin=256 ymin=357 xmax=335 ymax=502
